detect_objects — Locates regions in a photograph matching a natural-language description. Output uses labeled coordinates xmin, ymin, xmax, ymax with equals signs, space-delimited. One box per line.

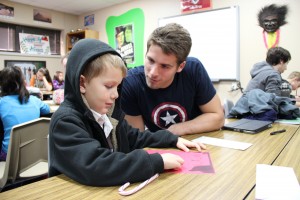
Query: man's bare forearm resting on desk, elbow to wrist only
xmin=168 ymin=113 xmax=224 ymax=135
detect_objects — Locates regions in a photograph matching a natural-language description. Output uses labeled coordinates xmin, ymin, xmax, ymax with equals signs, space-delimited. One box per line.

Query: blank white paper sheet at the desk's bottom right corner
xmin=255 ymin=164 xmax=300 ymax=200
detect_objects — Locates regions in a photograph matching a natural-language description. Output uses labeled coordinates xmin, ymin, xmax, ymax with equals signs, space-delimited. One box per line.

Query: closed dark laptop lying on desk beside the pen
xmin=222 ymin=119 xmax=273 ymax=134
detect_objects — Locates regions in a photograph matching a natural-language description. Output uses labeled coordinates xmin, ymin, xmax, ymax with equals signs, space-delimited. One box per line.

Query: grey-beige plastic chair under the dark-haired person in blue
xmin=0 ymin=117 xmax=50 ymax=191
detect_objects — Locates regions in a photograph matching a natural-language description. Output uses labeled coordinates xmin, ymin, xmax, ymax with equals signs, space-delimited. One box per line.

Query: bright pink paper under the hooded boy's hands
xmin=147 ymin=149 xmax=215 ymax=174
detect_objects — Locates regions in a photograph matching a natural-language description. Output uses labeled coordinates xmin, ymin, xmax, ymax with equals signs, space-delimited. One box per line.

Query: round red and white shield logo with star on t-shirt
xmin=152 ymin=102 xmax=187 ymax=129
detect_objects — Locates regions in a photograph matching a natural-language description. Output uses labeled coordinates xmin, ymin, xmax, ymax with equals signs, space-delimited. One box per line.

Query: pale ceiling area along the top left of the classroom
xmin=10 ymin=0 xmax=131 ymax=15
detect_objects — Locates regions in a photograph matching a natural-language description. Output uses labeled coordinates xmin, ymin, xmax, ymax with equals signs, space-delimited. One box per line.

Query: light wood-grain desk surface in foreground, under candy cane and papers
xmin=0 ymin=123 xmax=300 ymax=200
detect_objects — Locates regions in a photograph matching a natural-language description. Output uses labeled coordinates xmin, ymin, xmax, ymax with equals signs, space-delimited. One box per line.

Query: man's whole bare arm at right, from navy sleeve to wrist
xmin=168 ymin=94 xmax=225 ymax=135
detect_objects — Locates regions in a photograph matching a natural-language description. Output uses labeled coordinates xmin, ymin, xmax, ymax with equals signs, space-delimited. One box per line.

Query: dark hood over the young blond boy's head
xmin=64 ymin=39 xmax=121 ymax=111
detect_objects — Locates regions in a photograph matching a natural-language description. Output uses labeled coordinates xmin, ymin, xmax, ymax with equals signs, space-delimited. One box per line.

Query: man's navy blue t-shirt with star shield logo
xmin=121 ymin=57 xmax=216 ymax=131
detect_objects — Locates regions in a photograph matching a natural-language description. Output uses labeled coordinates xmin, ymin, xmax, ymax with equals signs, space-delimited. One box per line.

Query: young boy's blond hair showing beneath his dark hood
xmin=82 ymin=53 xmax=127 ymax=82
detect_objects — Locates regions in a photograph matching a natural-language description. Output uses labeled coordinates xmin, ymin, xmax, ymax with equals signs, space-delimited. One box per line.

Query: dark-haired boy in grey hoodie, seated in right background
xmin=245 ymin=47 xmax=292 ymax=96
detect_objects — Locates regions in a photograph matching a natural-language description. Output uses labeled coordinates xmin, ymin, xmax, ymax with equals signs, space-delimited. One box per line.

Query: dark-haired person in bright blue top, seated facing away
xmin=0 ymin=66 xmax=50 ymax=161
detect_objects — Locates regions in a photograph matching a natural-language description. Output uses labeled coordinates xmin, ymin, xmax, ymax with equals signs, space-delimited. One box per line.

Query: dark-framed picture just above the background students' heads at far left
xmin=4 ymin=60 xmax=46 ymax=86
